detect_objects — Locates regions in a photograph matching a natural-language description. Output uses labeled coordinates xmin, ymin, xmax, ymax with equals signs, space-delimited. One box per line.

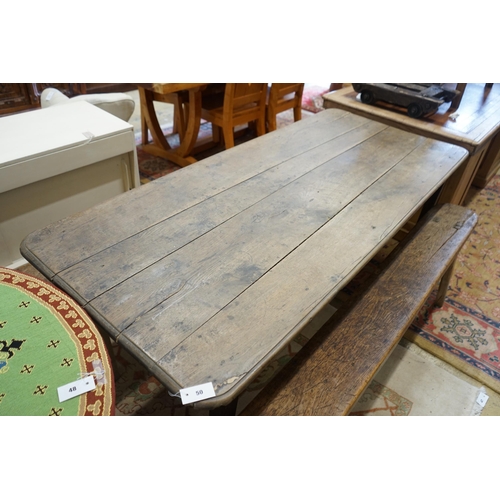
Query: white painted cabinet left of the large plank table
xmin=0 ymin=102 xmax=139 ymax=267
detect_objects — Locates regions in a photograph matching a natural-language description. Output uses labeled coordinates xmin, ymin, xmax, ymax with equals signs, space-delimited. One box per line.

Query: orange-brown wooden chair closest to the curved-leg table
xmin=201 ymin=83 xmax=267 ymax=149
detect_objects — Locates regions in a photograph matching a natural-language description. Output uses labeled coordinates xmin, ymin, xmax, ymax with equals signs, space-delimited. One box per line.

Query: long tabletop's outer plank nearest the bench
xmin=119 ymin=141 xmax=466 ymax=404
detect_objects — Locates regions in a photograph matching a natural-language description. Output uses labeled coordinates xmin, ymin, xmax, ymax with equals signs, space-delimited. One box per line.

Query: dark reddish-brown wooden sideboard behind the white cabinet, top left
xmin=0 ymin=83 xmax=136 ymax=115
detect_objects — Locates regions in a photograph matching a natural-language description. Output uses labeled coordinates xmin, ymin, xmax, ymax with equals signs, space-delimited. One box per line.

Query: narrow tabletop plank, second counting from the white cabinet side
xmin=54 ymin=122 xmax=387 ymax=302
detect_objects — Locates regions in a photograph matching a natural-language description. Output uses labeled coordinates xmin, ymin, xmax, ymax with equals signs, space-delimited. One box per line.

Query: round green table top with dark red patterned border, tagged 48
xmin=0 ymin=268 xmax=115 ymax=416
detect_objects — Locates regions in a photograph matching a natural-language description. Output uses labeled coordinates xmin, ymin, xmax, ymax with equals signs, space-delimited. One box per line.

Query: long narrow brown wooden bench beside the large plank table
xmin=241 ymin=204 xmax=477 ymax=415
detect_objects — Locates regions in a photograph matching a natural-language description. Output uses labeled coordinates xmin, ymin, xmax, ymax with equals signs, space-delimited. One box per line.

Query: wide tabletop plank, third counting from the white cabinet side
xmin=89 ymin=125 xmax=426 ymax=344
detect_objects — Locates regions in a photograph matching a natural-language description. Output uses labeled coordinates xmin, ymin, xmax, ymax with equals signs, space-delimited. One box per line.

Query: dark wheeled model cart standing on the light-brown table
xmin=352 ymin=83 xmax=460 ymax=118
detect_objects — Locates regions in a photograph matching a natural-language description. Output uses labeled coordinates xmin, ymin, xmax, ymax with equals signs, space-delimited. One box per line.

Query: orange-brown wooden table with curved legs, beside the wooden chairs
xmin=137 ymin=83 xmax=207 ymax=167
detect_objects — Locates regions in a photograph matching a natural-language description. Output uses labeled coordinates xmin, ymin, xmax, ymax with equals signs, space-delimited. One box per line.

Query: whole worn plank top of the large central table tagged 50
xmin=21 ymin=110 xmax=468 ymax=408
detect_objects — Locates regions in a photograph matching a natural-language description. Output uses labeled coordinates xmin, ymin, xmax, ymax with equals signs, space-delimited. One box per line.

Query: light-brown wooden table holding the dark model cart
xmin=323 ymin=83 xmax=500 ymax=205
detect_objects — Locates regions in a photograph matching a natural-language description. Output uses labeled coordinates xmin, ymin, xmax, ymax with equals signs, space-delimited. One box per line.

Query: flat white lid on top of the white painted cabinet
xmin=0 ymin=101 xmax=133 ymax=168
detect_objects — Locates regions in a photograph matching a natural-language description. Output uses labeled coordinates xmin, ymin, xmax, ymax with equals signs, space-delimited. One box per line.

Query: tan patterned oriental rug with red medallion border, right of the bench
xmin=405 ymin=174 xmax=500 ymax=392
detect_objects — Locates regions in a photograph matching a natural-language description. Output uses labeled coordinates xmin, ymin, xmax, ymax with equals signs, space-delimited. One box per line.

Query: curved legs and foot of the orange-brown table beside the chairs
xmin=139 ymin=87 xmax=201 ymax=167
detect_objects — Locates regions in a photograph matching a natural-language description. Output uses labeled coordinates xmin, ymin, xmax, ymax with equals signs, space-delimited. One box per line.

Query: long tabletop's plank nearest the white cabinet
xmin=21 ymin=110 xmax=366 ymax=277
